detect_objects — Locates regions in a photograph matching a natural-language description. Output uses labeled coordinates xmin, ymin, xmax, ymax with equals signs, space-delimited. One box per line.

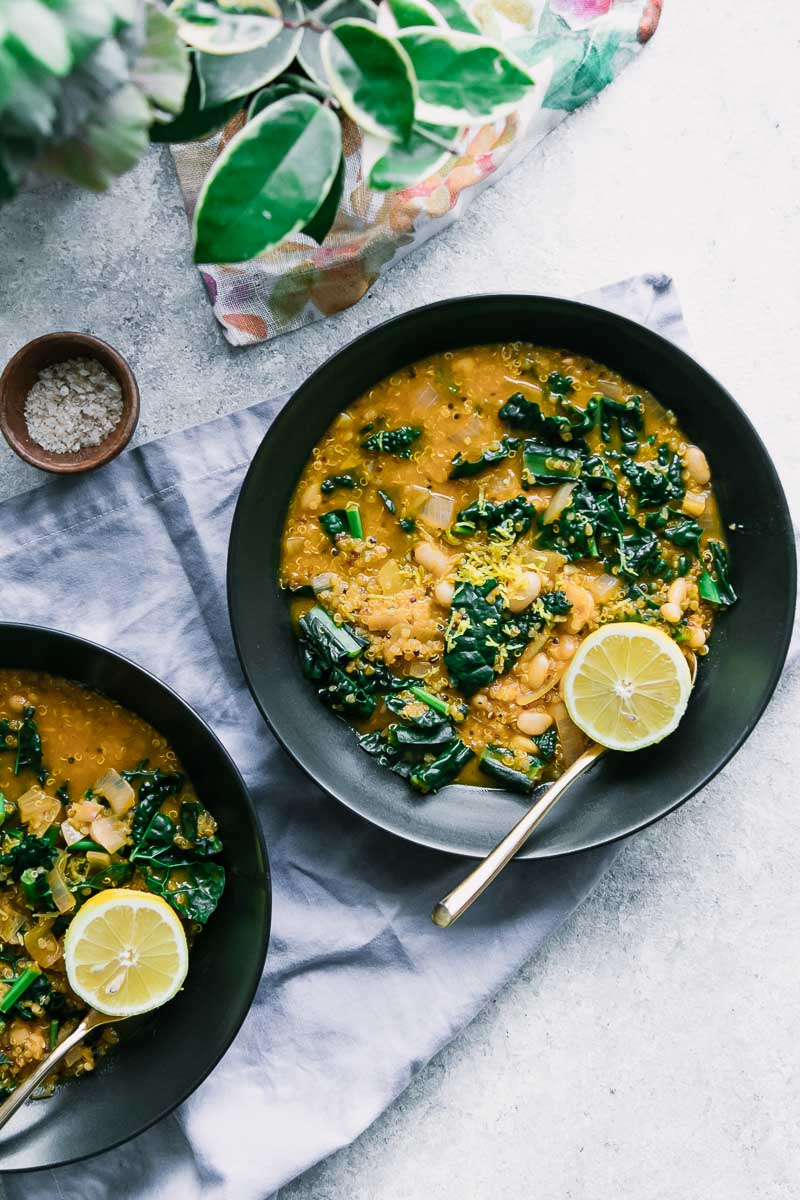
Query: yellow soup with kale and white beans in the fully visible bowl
xmin=281 ymin=342 xmax=729 ymax=792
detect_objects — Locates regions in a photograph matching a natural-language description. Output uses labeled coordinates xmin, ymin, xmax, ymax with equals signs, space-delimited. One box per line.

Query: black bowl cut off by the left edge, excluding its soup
xmin=0 ymin=622 xmax=271 ymax=1171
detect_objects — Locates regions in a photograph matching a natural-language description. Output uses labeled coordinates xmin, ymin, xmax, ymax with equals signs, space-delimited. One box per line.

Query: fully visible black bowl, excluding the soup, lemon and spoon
xmin=228 ymin=295 xmax=796 ymax=858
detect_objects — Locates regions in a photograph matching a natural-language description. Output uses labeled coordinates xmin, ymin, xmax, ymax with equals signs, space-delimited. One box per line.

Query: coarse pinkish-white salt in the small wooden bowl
xmin=25 ymin=359 xmax=122 ymax=454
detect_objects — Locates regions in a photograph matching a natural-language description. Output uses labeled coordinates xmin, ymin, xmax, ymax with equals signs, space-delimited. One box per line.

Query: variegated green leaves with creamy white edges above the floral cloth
xmin=172 ymin=0 xmax=533 ymax=262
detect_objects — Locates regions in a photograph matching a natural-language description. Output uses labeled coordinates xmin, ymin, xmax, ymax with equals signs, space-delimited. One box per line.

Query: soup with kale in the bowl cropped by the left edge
xmin=0 ymin=670 xmax=224 ymax=1097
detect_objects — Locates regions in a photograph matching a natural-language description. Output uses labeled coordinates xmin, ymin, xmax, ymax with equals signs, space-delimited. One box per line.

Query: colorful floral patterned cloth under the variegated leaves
xmin=174 ymin=0 xmax=662 ymax=346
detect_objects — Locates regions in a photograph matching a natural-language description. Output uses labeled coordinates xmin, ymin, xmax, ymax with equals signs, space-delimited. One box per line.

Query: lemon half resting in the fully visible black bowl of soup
xmin=564 ymin=623 xmax=692 ymax=750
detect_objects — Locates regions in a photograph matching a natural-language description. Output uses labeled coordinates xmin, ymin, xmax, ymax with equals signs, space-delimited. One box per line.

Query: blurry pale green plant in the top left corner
xmin=0 ymin=0 xmax=190 ymax=200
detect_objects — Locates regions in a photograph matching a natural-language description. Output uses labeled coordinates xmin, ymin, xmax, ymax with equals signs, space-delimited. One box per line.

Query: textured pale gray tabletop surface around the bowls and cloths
xmin=0 ymin=0 xmax=800 ymax=1200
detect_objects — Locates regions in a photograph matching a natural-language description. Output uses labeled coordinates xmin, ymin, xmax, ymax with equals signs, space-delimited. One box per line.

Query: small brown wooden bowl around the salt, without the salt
xmin=0 ymin=329 xmax=142 ymax=475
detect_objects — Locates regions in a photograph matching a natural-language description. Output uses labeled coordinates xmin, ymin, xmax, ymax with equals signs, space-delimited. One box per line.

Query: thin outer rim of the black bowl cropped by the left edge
xmin=0 ymin=620 xmax=272 ymax=1175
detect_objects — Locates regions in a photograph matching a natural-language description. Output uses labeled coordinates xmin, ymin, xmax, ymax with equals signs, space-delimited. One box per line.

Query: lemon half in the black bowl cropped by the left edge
xmin=64 ymin=888 xmax=188 ymax=1016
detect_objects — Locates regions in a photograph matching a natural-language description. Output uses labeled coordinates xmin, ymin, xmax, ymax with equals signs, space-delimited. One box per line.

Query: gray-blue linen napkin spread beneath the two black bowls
xmin=0 ymin=276 xmax=685 ymax=1200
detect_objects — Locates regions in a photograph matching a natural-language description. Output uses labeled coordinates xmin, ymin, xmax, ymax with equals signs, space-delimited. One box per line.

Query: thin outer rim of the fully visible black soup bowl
xmin=227 ymin=292 xmax=798 ymax=860
